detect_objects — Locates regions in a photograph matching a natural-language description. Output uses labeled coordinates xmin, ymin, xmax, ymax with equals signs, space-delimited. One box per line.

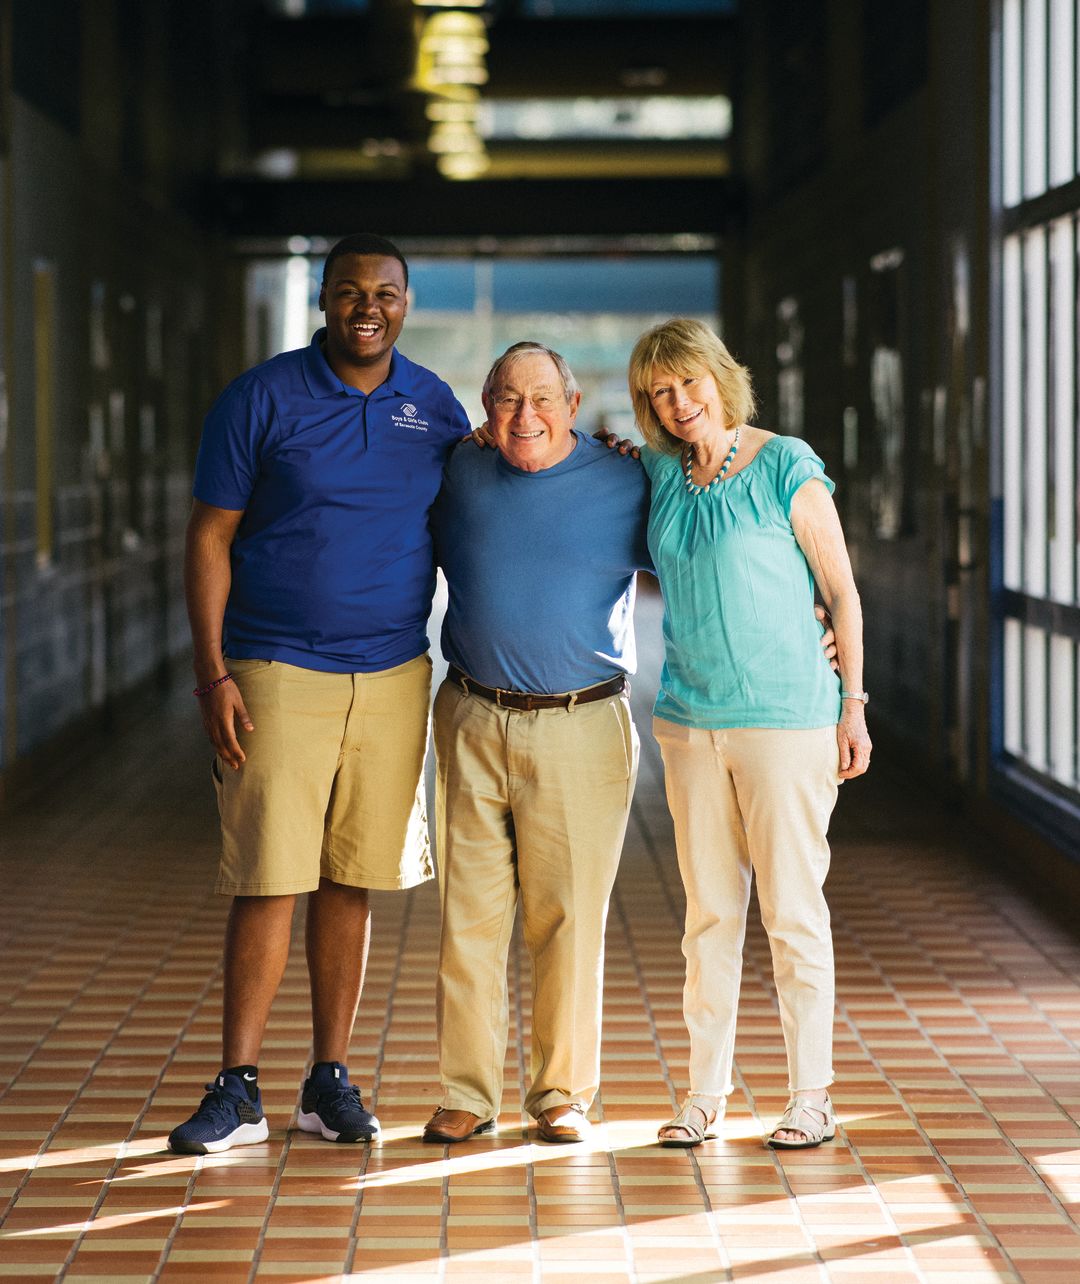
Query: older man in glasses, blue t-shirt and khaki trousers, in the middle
xmin=424 ymin=343 xmax=650 ymax=1143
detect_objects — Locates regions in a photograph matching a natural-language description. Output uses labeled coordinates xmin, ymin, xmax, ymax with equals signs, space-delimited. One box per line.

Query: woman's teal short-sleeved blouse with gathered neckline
xmin=642 ymin=437 xmax=840 ymax=729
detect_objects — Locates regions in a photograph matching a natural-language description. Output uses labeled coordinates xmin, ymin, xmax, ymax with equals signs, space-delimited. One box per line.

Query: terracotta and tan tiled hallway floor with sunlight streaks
xmin=0 ymin=590 xmax=1080 ymax=1284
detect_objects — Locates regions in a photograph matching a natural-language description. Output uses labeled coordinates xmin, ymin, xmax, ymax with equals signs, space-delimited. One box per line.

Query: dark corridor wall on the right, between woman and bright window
xmin=726 ymin=0 xmax=1080 ymax=886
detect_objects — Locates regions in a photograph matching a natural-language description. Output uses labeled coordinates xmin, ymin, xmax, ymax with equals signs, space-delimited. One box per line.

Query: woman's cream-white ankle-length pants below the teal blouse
xmin=652 ymin=718 xmax=839 ymax=1097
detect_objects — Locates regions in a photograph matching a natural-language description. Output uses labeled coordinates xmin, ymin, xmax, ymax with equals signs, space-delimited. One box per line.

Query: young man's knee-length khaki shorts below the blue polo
xmin=213 ymin=655 xmax=434 ymax=896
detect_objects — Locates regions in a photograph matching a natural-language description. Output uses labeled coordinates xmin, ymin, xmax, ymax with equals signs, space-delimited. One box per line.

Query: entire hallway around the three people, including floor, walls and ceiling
xmin=0 ymin=0 xmax=1080 ymax=1284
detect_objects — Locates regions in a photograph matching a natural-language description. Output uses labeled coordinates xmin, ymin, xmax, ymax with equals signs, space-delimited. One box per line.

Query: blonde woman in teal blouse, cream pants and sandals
xmin=629 ymin=320 xmax=871 ymax=1149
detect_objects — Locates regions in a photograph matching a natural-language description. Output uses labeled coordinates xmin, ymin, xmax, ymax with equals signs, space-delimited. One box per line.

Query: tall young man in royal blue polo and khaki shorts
xmin=170 ymin=234 xmax=469 ymax=1154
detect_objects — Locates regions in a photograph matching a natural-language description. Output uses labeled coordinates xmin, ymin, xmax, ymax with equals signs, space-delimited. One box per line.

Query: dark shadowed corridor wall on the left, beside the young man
xmin=0 ymin=0 xmax=238 ymax=787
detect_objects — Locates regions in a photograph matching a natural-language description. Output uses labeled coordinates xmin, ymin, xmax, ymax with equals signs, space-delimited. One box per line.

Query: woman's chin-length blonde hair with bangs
xmin=628 ymin=317 xmax=756 ymax=455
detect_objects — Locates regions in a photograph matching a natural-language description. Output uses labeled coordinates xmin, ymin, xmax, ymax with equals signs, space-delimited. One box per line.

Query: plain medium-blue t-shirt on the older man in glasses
xmin=431 ymin=431 xmax=651 ymax=695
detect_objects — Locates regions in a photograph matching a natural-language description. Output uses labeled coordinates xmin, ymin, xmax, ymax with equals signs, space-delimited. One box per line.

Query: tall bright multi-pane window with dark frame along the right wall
xmin=997 ymin=0 xmax=1080 ymax=803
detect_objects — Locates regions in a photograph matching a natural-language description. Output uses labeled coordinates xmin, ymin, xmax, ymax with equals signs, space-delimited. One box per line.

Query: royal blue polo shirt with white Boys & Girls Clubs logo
xmin=194 ymin=330 xmax=469 ymax=673
